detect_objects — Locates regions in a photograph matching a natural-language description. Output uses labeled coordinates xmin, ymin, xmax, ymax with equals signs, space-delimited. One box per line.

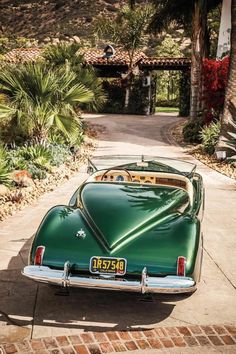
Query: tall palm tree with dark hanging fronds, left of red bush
xmin=150 ymin=0 xmax=221 ymax=118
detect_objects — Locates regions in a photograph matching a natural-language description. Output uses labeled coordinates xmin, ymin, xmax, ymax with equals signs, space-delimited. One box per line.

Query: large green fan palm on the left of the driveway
xmin=0 ymin=62 xmax=94 ymax=142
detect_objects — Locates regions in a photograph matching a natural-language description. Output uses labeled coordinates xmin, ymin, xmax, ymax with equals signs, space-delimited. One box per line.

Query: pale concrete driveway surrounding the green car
xmin=0 ymin=115 xmax=236 ymax=343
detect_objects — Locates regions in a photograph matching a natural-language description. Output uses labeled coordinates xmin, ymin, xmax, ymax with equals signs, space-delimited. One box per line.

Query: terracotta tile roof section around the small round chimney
xmin=83 ymin=49 xmax=146 ymax=65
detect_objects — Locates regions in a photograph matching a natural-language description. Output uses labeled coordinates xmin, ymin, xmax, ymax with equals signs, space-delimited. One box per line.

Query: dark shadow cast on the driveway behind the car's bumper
xmin=0 ymin=238 xmax=192 ymax=342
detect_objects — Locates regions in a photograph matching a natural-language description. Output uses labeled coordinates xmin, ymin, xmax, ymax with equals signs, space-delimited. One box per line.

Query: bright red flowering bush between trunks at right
xmin=203 ymin=56 xmax=229 ymax=124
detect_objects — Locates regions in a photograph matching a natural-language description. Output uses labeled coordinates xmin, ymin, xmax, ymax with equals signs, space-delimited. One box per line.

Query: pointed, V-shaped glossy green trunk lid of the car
xmin=80 ymin=182 xmax=188 ymax=251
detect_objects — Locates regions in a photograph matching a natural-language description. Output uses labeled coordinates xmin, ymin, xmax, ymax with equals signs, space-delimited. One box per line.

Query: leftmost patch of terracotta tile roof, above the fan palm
xmin=4 ymin=47 xmax=42 ymax=63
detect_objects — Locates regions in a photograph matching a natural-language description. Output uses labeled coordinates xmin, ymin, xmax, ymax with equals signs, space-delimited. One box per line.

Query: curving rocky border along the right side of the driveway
xmin=170 ymin=121 xmax=236 ymax=179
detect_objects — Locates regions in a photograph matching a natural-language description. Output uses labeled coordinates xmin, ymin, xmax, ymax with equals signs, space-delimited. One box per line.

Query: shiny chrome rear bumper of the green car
xmin=22 ymin=264 xmax=196 ymax=294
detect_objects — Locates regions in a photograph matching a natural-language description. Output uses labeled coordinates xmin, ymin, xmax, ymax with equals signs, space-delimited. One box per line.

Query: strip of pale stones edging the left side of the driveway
xmin=0 ymin=131 xmax=96 ymax=221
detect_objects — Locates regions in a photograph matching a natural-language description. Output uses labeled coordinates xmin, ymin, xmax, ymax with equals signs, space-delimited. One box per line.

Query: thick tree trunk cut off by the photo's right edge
xmin=216 ymin=0 xmax=236 ymax=155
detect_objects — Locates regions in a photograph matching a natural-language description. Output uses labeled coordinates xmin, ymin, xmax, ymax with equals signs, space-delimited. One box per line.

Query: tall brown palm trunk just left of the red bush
xmin=190 ymin=0 xmax=207 ymax=119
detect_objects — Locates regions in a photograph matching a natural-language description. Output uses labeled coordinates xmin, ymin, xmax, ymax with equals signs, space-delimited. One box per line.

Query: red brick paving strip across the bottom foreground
xmin=0 ymin=325 xmax=236 ymax=354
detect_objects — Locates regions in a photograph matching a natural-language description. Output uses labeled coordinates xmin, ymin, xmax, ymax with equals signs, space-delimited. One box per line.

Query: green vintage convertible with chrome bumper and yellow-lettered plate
xmin=22 ymin=156 xmax=204 ymax=293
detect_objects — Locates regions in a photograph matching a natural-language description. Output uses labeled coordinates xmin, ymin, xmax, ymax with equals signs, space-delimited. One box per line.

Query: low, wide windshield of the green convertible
xmin=88 ymin=155 xmax=196 ymax=176
